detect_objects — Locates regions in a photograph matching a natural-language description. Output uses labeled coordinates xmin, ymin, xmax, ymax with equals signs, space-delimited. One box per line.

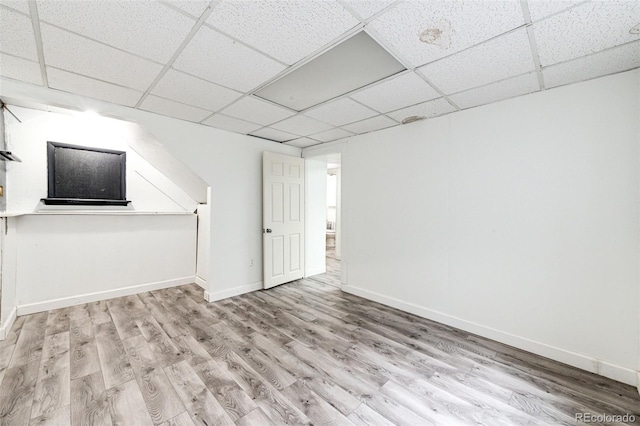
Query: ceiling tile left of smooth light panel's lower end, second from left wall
xmin=151 ymin=70 xmax=242 ymax=111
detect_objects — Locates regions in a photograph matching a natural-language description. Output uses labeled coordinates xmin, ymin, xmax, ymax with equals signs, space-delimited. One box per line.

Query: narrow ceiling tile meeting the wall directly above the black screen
xmin=47 ymin=67 xmax=142 ymax=106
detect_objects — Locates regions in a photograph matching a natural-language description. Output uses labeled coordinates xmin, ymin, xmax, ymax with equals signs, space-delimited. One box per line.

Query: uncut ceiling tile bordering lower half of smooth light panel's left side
xmin=173 ymin=27 xmax=285 ymax=92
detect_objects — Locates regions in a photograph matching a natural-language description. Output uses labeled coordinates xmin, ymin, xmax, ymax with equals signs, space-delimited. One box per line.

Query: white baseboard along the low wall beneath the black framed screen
xmin=18 ymin=275 xmax=195 ymax=316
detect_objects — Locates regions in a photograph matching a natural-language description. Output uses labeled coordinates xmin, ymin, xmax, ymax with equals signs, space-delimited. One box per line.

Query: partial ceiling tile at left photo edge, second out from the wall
xmin=0 ymin=7 xmax=38 ymax=61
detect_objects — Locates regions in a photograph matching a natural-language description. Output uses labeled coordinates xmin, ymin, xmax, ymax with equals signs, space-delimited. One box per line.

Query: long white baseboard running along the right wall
xmin=342 ymin=285 xmax=640 ymax=391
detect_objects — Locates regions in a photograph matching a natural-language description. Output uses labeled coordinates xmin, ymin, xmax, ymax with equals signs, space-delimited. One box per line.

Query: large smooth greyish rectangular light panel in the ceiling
xmin=256 ymin=31 xmax=405 ymax=111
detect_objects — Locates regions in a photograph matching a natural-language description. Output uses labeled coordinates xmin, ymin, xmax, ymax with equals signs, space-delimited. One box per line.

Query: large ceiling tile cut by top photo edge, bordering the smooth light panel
xmin=207 ymin=0 xmax=358 ymax=64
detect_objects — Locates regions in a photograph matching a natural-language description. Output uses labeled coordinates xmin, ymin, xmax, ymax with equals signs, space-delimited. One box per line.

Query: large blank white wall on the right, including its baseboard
xmin=342 ymin=70 xmax=640 ymax=384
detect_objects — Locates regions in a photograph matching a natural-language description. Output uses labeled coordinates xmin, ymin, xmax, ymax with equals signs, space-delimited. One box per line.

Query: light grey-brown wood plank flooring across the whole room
xmin=0 ymin=271 xmax=640 ymax=426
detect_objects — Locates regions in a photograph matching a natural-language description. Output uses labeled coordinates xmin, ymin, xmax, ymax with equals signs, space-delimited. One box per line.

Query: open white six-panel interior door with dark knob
xmin=262 ymin=152 xmax=304 ymax=288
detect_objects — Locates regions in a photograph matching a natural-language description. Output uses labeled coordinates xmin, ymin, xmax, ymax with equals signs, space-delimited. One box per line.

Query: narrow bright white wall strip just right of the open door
xmin=304 ymin=158 xmax=327 ymax=277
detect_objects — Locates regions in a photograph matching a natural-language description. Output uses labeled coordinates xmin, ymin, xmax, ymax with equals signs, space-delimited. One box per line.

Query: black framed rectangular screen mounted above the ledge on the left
xmin=42 ymin=142 xmax=130 ymax=206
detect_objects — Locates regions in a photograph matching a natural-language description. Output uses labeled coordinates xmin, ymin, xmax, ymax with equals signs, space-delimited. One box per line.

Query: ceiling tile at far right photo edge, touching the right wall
xmin=542 ymin=42 xmax=640 ymax=88
